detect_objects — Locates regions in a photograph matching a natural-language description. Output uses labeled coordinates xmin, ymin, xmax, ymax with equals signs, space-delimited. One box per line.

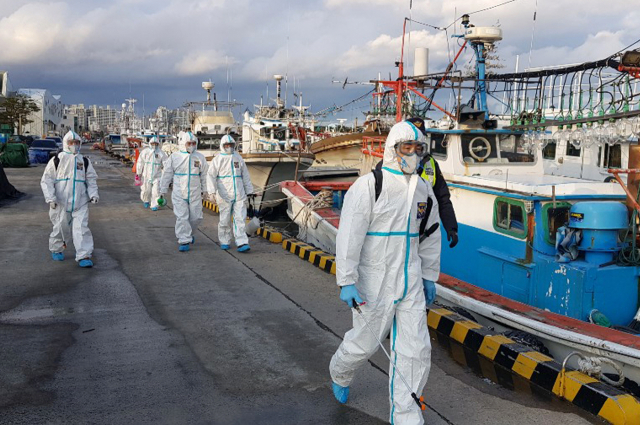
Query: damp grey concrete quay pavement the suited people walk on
xmin=0 ymin=153 xmax=602 ymax=425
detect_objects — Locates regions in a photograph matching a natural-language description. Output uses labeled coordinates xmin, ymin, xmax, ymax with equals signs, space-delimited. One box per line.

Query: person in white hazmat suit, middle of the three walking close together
xmin=159 ymin=131 xmax=208 ymax=252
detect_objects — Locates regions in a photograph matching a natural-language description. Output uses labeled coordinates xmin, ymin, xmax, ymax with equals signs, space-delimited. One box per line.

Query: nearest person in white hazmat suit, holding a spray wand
xmin=330 ymin=121 xmax=441 ymax=424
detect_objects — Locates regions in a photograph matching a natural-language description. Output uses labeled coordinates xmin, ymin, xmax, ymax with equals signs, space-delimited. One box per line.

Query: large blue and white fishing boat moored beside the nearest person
xmin=281 ymin=17 xmax=640 ymax=388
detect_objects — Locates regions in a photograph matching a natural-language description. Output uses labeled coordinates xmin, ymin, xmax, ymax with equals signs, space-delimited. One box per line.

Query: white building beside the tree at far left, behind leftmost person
xmin=18 ymin=89 xmax=63 ymax=137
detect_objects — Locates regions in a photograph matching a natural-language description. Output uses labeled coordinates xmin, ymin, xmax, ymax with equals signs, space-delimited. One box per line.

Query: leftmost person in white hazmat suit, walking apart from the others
xmin=40 ymin=131 xmax=100 ymax=267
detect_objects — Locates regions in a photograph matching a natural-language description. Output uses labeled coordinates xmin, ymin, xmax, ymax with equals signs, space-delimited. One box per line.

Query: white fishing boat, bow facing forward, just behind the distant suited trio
xmin=241 ymin=75 xmax=315 ymax=212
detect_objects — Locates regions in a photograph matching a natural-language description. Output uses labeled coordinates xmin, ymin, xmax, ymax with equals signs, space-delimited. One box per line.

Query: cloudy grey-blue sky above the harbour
xmin=0 ymin=0 xmax=640 ymax=119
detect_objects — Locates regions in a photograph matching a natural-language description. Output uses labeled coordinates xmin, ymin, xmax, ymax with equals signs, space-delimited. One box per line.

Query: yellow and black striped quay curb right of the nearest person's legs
xmin=427 ymin=308 xmax=640 ymax=425
